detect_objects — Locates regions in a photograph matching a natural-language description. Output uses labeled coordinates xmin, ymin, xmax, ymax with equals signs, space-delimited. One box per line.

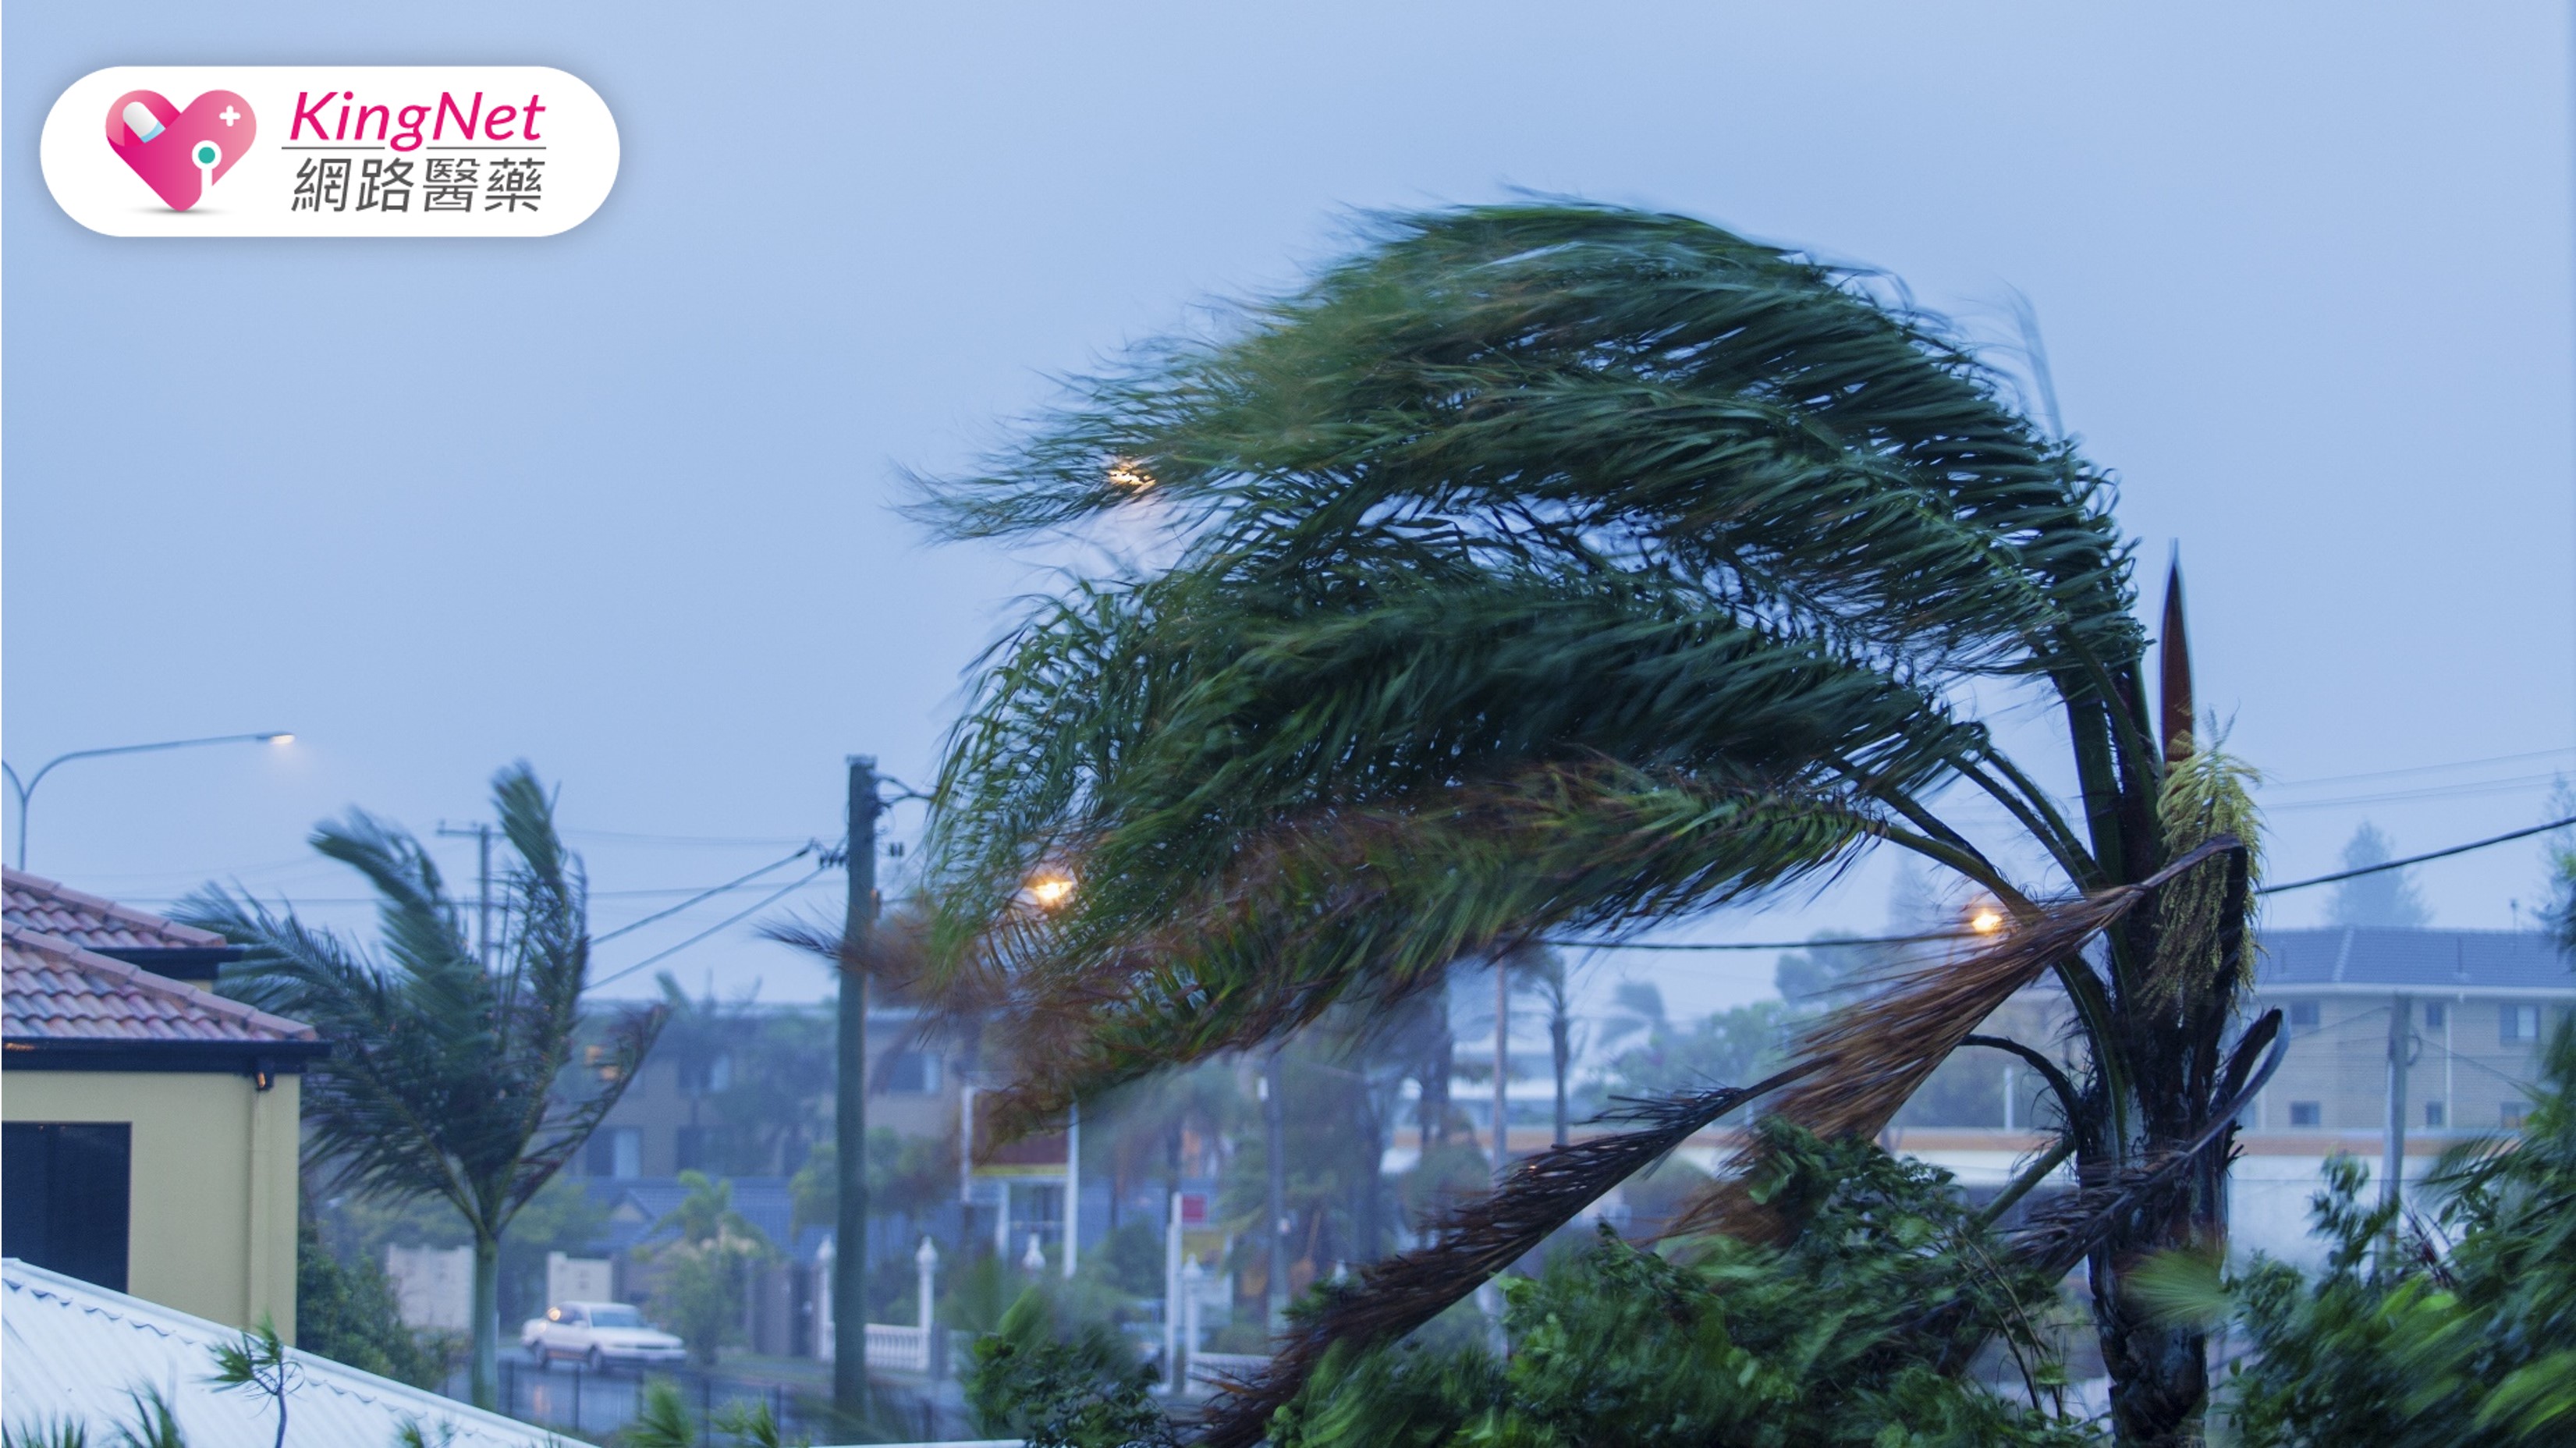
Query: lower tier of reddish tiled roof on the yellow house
xmin=0 ymin=922 xmax=314 ymax=1041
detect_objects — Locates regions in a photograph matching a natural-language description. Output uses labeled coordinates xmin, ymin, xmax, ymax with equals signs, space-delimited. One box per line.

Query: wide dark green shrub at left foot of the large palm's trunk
xmin=1270 ymin=1123 xmax=2097 ymax=1448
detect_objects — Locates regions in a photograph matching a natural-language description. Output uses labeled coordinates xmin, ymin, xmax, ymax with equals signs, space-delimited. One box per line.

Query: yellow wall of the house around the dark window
xmin=0 ymin=1070 xmax=304 ymax=1343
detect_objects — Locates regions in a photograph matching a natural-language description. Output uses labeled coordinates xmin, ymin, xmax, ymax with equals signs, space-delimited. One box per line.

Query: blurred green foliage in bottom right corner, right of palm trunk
xmin=2228 ymin=1023 xmax=2576 ymax=1448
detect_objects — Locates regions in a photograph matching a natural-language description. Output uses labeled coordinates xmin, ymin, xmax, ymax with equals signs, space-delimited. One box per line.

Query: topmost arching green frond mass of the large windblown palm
xmin=920 ymin=204 xmax=2135 ymax=667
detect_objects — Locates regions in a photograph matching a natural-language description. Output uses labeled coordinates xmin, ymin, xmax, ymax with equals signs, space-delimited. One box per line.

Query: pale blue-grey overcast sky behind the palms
xmin=0 ymin=0 xmax=2576 ymax=1010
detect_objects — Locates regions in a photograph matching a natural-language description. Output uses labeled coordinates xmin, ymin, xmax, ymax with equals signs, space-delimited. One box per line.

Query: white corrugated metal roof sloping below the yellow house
xmin=0 ymin=1258 xmax=559 ymax=1448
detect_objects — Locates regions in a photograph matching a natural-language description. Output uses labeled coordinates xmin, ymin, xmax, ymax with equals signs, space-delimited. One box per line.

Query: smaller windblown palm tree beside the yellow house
xmin=180 ymin=763 xmax=662 ymax=1407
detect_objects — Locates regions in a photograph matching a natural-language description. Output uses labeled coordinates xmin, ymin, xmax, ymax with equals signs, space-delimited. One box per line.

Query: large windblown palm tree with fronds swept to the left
xmin=920 ymin=204 xmax=2275 ymax=1443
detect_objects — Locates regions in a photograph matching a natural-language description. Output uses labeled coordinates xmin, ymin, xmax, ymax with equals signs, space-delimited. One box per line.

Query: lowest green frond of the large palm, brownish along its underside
xmin=976 ymin=763 xmax=1875 ymax=1128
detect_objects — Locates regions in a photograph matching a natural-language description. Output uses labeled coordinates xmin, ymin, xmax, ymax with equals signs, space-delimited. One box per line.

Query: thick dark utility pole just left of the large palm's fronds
xmin=832 ymin=755 xmax=881 ymax=1430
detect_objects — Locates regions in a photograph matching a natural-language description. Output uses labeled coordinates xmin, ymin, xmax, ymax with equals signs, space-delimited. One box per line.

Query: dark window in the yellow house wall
xmin=0 ymin=1121 xmax=134 ymax=1291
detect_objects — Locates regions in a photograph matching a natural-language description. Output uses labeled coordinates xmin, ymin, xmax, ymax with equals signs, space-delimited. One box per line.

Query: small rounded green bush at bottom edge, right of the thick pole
xmin=963 ymin=1286 xmax=1172 ymax=1448
